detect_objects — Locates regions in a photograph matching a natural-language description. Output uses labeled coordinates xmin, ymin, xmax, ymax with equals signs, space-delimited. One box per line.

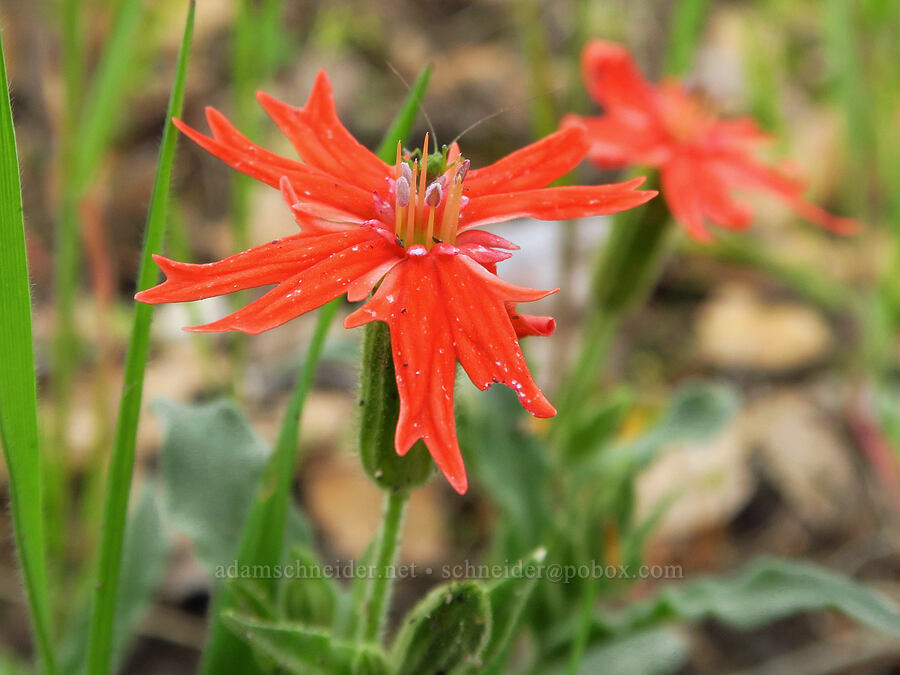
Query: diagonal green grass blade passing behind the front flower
xmin=201 ymin=66 xmax=431 ymax=675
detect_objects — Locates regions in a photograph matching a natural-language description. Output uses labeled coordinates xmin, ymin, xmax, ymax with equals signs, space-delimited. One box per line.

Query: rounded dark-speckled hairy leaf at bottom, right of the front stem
xmin=391 ymin=581 xmax=491 ymax=675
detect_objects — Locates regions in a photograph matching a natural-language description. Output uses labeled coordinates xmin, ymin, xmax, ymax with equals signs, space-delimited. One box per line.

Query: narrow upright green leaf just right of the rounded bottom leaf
xmin=482 ymin=548 xmax=547 ymax=673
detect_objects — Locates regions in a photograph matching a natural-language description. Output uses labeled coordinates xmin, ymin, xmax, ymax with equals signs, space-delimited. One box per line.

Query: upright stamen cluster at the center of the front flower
xmin=393 ymin=133 xmax=469 ymax=250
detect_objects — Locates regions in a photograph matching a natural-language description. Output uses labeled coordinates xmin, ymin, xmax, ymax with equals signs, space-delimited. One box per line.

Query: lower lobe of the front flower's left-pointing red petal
xmin=187 ymin=230 xmax=397 ymax=334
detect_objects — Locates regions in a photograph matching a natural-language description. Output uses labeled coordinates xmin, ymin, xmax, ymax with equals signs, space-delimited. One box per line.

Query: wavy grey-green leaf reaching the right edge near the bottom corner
xmin=628 ymin=558 xmax=900 ymax=635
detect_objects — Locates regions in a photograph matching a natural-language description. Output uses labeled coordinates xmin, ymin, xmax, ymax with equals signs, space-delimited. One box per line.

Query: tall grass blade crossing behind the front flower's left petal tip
xmin=88 ymin=1 xmax=195 ymax=673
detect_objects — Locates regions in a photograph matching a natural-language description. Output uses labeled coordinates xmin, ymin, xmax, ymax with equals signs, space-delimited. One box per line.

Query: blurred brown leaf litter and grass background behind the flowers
xmin=0 ymin=0 xmax=900 ymax=673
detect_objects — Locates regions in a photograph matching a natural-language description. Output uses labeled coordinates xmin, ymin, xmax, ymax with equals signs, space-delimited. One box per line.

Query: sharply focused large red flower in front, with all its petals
xmin=135 ymin=72 xmax=656 ymax=493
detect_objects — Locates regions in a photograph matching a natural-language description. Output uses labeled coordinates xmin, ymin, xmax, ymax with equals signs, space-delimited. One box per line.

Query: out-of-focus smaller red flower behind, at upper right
xmin=563 ymin=40 xmax=858 ymax=240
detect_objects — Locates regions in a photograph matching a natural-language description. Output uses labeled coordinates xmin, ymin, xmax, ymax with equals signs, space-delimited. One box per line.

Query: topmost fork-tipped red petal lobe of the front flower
xmin=257 ymin=71 xmax=390 ymax=191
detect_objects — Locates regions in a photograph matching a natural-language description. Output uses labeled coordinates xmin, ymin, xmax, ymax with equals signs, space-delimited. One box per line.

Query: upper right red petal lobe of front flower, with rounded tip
xmin=463 ymin=127 xmax=588 ymax=197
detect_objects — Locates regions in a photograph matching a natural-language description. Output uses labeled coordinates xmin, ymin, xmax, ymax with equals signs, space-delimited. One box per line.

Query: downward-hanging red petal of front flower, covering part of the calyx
xmin=344 ymin=245 xmax=556 ymax=492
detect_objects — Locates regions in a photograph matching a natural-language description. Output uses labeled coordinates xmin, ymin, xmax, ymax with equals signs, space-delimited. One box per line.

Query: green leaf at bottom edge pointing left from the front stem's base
xmin=222 ymin=610 xmax=389 ymax=675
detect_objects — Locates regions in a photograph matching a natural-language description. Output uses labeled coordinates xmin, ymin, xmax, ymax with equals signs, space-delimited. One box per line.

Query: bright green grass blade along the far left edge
xmin=0 ymin=27 xmax=56 ymax=673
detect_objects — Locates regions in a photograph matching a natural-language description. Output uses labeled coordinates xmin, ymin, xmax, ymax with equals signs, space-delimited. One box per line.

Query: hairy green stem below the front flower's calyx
xmin=362 ymin=490 xmax=409 ymax=642
